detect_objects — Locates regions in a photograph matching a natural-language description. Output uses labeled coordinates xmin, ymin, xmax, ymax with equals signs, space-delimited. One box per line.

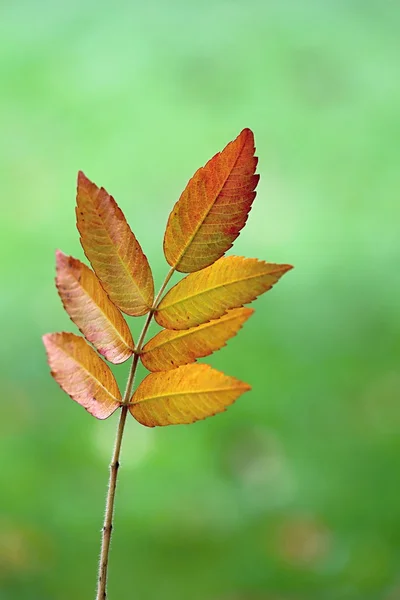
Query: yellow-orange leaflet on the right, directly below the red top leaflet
xmin=155 ymin=256 xmax=292 ymax=329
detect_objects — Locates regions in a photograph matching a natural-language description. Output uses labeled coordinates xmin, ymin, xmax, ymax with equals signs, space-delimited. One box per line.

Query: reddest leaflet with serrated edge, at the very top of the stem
xmin=164 ymin=129 xmax=259 ymax=273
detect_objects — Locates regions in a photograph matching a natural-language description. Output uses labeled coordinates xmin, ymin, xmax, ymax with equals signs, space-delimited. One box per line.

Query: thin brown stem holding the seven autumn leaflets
xmin=96 ymin=268 xmax=175 ymax=600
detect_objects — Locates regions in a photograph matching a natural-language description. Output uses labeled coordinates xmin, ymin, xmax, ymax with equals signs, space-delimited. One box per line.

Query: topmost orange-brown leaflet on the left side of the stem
xmin=76 ymin=171 xmax=154 ymax=316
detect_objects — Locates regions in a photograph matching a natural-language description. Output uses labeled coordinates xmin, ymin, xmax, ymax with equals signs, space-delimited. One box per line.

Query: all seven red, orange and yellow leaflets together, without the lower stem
xmin=43 ymin=129 xmax=291 ymax=427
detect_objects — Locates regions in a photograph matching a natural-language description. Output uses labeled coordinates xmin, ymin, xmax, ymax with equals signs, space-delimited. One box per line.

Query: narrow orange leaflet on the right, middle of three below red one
xmin=140 ymin=308 xmax=254 ymax=371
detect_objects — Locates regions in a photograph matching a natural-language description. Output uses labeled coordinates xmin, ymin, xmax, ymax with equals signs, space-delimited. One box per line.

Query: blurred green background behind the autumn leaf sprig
xmin=0 ymin=0 xmax=400 ymax=600
